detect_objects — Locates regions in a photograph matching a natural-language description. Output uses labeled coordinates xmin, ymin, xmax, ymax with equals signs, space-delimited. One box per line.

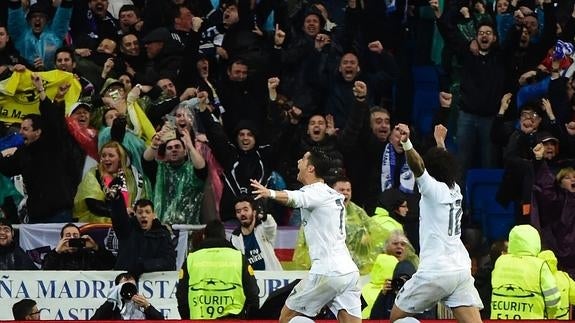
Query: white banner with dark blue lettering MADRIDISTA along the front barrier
xmin=0 ymin=271 xmax=307 ymax=320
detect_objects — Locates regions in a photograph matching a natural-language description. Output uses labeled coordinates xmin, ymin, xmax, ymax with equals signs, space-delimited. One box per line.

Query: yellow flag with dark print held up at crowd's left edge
xmin=0 ymin=70 xmax=82 ymax=123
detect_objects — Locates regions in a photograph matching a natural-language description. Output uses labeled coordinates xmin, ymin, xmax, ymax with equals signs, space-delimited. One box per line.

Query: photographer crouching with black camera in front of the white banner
xmin=90 ymin=272 xmax=164 ymax=321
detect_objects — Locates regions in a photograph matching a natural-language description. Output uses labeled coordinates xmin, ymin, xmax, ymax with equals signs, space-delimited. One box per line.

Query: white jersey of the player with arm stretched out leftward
xmin=286 ymin=183 xmax=358 ymax=276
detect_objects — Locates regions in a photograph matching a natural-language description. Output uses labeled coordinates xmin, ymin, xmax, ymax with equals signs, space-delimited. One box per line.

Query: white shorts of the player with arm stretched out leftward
xmin=286 ymin=271 xmax=361 ymax=318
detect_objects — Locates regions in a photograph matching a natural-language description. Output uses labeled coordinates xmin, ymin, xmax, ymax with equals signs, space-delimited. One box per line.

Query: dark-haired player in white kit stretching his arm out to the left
xmin=252 ymin=151 xmax=361 ymax=323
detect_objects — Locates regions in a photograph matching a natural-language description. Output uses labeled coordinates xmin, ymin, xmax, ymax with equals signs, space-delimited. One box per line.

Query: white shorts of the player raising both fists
xmin=395 ymin=270 xmax=483 ymax=313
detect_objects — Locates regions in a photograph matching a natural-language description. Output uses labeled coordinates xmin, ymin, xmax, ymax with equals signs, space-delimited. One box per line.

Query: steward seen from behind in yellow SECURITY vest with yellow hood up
xmin=491 ymin=224 xmax=561 ymax=320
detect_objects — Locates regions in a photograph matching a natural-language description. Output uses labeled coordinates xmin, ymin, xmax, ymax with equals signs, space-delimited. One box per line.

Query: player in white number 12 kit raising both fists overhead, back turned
xmin=390 ymin=124 xmax=483 ymax=323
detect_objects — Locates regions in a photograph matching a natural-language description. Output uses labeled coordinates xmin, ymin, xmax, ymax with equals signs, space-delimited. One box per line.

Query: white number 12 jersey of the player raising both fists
xmin=416 ymin=170 xmax=471 ymax=271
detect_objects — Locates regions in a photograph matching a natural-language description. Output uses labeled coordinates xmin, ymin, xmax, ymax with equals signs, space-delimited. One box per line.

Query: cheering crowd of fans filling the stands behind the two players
xmin=0 ymin=0 xmax=575 ymax=318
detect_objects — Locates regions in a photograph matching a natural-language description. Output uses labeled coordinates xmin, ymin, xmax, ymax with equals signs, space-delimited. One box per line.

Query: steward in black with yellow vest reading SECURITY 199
xmin=176 ymin=220 xmax=259 ymax=320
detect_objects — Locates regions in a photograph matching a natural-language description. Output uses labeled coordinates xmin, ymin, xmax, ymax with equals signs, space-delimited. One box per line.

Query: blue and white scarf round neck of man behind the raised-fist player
xmin=381 ymin=143 xmax=415 ymax=193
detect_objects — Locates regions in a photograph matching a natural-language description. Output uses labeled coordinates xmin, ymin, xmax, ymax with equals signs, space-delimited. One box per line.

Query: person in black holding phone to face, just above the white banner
xmin=42 ymin=223 xmax=116 ymax=270
